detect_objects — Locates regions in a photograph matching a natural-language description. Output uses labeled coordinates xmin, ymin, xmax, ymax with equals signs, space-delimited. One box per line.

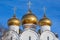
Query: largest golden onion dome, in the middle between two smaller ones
xmin=22 ymin=10 xmax=37 ymax=25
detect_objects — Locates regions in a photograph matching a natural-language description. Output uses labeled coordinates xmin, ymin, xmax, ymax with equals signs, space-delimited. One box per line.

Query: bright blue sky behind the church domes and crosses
xmin=0 ymin=0 xmax=60 ymax=36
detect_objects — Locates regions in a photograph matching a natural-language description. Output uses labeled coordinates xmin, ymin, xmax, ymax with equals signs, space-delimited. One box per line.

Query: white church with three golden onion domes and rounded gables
xmin=1 ymin=1 xmax=59 ymax=40
